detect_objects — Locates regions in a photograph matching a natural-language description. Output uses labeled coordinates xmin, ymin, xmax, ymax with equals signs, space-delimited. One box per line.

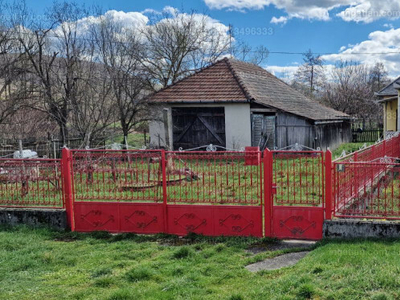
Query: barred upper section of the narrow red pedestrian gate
xmin=272 ymin=151 xmax=325 ymax=206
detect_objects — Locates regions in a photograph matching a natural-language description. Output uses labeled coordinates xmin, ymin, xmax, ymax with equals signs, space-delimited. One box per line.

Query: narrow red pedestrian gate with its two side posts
xmin=264 ymin=150 xmax=331 ymax=240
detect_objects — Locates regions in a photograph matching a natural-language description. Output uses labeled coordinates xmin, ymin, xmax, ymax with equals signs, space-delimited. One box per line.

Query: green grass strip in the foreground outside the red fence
xmin=0 ymin=227 xmax=400 ymax=300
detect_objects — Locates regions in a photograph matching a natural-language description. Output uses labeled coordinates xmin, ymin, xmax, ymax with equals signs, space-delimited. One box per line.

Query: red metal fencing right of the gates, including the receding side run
xmin=333 ymin=137 xmax=400 ymax=219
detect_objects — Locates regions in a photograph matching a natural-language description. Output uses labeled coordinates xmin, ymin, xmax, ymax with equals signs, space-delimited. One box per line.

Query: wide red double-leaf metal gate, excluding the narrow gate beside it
xmin=64 ymin=150 xmax=262 ymax=237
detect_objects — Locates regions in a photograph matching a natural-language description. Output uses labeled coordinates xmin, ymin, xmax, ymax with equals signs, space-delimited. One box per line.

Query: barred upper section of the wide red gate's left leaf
xmin=72 ymin=150 xmax=163 ymax=202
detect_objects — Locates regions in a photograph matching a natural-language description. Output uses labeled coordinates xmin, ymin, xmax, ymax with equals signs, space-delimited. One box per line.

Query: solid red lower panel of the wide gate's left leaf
xmin=74 ymin=202 xmax=164 ymax=234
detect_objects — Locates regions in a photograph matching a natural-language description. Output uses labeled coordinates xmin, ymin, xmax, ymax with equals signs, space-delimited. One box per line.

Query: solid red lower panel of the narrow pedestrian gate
xmin=271 ymin=206 xmax=324 ymax=240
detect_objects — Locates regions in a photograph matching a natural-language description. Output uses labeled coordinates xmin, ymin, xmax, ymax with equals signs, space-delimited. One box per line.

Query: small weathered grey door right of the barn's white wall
xmin=251 ymin=114 xmax=275 ymax=150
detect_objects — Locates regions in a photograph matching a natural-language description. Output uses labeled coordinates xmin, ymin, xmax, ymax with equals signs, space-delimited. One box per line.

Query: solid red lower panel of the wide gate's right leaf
xmin=167 ymin=205 xmax=262 ymax=237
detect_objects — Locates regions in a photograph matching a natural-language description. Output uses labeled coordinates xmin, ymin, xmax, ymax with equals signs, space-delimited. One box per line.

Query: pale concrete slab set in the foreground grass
xmin=246 ymin=251 xmax=309 ymax=272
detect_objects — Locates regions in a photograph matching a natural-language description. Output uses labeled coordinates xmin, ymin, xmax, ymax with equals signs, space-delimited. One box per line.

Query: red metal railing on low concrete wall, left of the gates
xmin=0 ymin=159 xmax=64 ymax=208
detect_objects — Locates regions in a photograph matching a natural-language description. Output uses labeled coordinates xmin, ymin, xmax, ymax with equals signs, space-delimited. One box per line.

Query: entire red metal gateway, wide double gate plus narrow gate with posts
xmin=63 ymin=149 xmax=331 ymax=240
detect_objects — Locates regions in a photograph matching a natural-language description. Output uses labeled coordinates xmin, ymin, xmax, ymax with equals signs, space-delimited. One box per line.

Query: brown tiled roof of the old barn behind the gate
xmin=150 ymin=58 xmax=348 ymax=120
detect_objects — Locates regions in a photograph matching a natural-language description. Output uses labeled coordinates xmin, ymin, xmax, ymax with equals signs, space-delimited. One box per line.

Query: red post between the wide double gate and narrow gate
xmin=264 ymin=149 xmax=274 ymax=237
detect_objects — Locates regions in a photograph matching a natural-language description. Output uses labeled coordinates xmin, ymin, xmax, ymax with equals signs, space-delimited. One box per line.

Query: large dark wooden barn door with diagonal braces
xmin=172 ymin=107 xmax=226 ymax=149
